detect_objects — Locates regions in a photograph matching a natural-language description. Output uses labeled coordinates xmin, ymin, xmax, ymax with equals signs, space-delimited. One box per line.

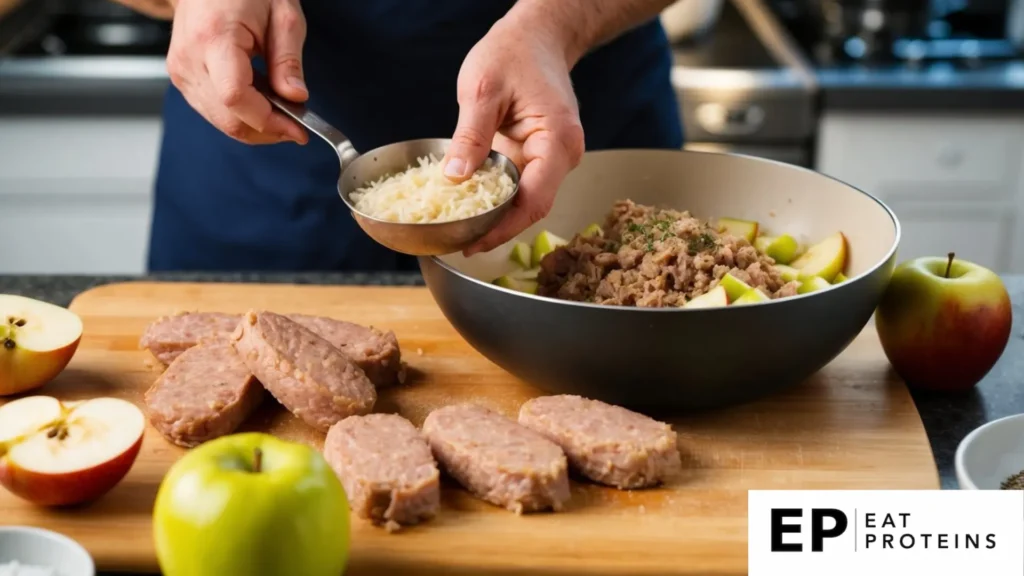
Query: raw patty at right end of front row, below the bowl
xmin=519 ymin=396 xmax=681 ymax=489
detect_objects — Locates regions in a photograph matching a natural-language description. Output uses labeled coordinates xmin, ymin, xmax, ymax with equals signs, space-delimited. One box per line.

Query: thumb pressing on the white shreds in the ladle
xmin=443 ymin=80 xmax=503 ymax=182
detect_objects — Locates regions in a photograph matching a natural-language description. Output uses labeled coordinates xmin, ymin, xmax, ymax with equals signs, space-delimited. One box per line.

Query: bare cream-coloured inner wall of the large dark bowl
xmin=439 ymin=150 xmax=899 ymax=282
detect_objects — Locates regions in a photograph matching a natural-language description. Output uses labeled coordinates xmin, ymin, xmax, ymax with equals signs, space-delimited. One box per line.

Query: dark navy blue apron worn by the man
xmin=148 ymin=0 xmax=683 ymax=272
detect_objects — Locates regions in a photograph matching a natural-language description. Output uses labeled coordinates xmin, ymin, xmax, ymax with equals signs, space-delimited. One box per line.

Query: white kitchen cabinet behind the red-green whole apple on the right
xmin=815 ymin=112 xmax=1024 ymax=274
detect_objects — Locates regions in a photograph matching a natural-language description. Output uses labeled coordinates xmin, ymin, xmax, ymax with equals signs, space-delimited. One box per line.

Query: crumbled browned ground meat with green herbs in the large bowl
xmin=538 ymin=200 xmax=800 ymax=307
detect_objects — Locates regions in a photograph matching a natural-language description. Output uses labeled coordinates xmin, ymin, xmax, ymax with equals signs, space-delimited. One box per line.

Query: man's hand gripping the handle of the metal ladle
xmin=167 ymin=0 xmax=309 ymax=143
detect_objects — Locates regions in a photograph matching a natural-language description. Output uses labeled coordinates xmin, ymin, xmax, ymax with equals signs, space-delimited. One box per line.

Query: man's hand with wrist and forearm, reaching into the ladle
xmin=444 ymin=0 xmax=672 ymax=255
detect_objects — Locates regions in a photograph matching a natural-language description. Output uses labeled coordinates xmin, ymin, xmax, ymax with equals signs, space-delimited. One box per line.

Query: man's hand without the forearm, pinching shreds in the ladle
xmin=444 ymin=10 xmax=585 ymax=255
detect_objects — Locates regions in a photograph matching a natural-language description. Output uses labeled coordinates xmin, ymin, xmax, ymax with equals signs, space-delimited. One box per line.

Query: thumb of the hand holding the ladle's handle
xmin=266 ymin=0 xmax=309 ymax=101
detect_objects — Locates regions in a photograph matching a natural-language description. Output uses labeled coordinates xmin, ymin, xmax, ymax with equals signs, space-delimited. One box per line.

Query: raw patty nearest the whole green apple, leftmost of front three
xmin=324 ymin=414 xmax=440 ymax=531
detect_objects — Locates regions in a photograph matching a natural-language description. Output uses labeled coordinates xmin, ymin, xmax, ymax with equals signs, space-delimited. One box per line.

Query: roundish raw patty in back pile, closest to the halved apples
xmin=144 ymin=342 xmax=264 ymax=448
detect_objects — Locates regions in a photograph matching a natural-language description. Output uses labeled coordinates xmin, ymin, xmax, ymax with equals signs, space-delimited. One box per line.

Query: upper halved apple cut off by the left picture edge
xmin=0 ymin=294 xmax=82 ymax=396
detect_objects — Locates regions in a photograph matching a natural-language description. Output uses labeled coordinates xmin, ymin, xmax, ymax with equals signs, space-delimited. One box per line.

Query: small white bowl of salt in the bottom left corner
xmin=0 ymin=526 xmax=96 ymax=576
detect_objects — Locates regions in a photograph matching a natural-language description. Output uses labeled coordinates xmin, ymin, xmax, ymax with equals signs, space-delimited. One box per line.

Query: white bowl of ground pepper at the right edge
xmin=954 ymin=414 xmax=1024 ymax=490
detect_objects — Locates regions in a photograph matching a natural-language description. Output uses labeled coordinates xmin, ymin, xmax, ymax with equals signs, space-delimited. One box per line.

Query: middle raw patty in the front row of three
xmin=423 ymin=404 xmax=569 ymax=513
